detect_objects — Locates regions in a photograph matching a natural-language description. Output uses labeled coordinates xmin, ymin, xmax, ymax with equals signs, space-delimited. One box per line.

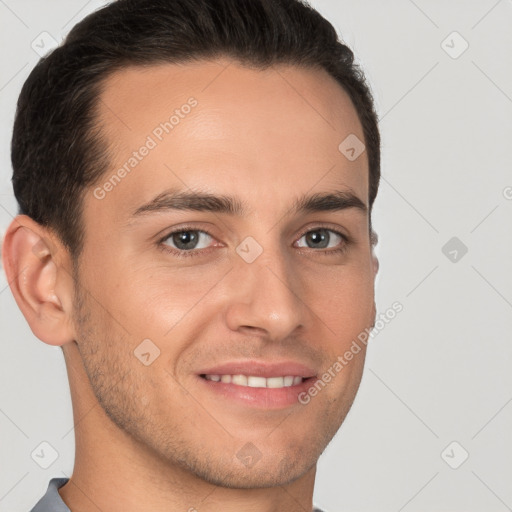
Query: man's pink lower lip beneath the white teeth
xmin=198 ymin=376 xmax=315 ymax=409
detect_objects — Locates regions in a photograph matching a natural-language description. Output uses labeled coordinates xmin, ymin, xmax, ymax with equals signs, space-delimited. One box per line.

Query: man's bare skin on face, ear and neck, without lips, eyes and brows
xmin=3 ymin=60 xmax=378 ymax=512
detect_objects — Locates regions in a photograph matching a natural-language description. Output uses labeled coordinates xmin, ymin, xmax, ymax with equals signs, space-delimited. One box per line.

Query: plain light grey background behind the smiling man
xmin=0 ymin=0 xmax=512 ymax=512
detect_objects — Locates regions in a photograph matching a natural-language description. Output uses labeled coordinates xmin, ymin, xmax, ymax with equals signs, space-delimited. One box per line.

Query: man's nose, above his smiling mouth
xmin=226 ymin=246 xmax=311 ymax=342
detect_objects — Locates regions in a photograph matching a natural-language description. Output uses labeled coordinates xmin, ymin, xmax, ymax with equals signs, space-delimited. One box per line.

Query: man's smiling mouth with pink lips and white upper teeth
xmin=197 ymin=362 xmax=317 ymax=410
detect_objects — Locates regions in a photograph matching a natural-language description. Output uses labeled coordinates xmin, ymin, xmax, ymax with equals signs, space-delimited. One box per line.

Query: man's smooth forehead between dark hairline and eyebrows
xmin=92 ymin=60 xmax=368 ymax=218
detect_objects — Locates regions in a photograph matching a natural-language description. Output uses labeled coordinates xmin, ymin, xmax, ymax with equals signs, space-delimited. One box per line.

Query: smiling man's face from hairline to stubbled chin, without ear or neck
xmin=71 ymin=61 xmax=375 ymax=487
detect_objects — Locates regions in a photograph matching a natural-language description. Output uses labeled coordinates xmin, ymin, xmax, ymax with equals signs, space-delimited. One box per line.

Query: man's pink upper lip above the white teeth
xmin=198 ymin=360 xmax=316 ymax=378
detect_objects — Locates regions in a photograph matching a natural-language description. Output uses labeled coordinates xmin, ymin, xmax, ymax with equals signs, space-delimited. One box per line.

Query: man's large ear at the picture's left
xmin=2 ymin=215 xmax=75 ymax=345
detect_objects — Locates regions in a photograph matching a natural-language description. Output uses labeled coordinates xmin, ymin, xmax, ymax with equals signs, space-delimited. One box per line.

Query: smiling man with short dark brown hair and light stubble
xmin=3 ymin=0 xmax=380 ymax=512
